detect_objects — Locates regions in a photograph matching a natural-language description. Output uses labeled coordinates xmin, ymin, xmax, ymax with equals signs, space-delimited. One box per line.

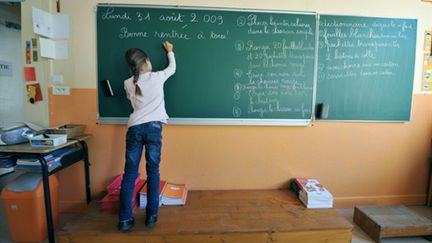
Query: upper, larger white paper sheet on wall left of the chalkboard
xmin=32 ymin=7 xmax=69 ymax=39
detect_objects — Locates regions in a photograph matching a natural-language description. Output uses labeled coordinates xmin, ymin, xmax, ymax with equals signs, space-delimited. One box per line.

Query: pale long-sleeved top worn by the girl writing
xmin=124 ymin=52 xmax=176 ymax=127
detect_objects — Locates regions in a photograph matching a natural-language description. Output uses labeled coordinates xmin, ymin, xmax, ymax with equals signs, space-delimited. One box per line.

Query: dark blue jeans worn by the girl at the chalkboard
xmin=119 ymin=121 xmax=162 ymax=221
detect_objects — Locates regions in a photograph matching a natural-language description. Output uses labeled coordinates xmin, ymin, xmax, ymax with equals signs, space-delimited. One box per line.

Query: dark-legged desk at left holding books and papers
xmin=0 ymin=135 xmax=91 ymax=243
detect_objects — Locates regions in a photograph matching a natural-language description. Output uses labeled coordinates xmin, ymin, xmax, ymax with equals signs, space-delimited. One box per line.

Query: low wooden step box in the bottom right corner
xmin=354 ymin=206 xmax=432 ymax=242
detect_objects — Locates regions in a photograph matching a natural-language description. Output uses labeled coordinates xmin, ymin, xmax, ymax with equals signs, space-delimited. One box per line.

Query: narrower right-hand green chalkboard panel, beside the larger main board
xmin=316 ymin=15 xmax=417 ymax=121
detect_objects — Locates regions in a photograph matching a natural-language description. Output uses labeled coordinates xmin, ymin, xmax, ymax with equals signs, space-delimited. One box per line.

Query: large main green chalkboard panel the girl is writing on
xmin=96 ymin=4 xmax=317 ymax=125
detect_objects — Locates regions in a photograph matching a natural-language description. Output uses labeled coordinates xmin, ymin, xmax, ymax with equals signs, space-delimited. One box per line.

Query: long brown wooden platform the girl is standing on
xmin=57 ymin=190 xmax=353 ymax=243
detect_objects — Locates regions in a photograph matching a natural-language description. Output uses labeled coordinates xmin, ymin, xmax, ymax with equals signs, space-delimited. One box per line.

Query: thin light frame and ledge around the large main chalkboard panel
xmin=96 ymin=3 xmax=319 ymax=126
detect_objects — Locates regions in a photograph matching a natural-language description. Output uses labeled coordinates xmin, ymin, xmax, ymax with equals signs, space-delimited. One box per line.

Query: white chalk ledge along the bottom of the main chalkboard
xmin=99 ymin=117 xmax=312 ymax=126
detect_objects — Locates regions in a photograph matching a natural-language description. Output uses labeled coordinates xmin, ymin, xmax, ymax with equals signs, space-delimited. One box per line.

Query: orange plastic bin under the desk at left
xmin=1 ymin=173 xmax=59 ymax=242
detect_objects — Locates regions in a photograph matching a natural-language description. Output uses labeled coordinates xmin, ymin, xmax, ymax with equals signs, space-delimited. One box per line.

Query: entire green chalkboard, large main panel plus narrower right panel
xmin=96 ymin=4 xmax=417 ymax=125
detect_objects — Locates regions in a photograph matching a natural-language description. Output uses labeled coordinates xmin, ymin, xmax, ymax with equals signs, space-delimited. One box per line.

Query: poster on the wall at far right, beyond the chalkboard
xmin=421 ymin=30 xmax=432 ymax=91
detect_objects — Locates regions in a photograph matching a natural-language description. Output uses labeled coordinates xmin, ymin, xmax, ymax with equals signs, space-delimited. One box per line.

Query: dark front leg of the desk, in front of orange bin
xmin=38 ymin=156 xmax=55 ymax=243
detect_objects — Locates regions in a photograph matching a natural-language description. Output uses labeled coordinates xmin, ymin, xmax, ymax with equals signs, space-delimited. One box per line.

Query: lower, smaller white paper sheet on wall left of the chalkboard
xmin=39 ymin=37 xmax=69 ymax=59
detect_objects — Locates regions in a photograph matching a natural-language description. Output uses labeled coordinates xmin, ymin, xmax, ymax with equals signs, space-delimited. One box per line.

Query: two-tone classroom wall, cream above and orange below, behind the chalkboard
xmin=26 ymin=0 xmax=432 ymax=211
